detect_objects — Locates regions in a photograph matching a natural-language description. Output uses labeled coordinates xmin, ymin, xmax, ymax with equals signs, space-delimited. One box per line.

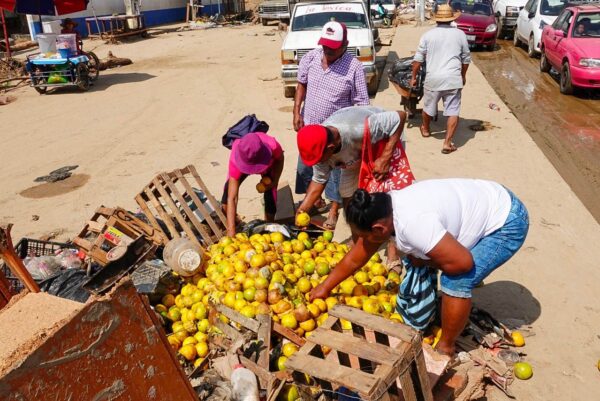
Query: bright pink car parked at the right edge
xmin=540 ymin=5 xmax=600 ymax=95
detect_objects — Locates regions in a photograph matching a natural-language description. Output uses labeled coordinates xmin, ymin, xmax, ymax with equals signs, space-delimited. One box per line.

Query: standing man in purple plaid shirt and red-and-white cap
xmin=294 ymin=21 xmax=369 ymax=230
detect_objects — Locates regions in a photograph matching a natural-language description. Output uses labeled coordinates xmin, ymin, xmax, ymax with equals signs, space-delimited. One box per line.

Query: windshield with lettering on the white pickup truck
xmin=292 ymin=3 xmax=368 ymax=31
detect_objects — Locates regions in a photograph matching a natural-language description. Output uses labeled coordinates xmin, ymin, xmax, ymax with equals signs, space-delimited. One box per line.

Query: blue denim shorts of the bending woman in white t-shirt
xmin=441 ymin=189 xmax=529 ymax=298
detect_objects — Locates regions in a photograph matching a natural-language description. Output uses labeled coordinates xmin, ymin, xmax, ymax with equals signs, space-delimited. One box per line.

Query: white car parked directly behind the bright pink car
xmin=513 ymin=0 xmax=568 ymax=57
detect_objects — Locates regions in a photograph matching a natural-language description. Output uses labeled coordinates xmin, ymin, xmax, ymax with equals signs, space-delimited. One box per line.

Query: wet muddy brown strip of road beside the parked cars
xmin=472 ymin=40 xmax=600 ymax=223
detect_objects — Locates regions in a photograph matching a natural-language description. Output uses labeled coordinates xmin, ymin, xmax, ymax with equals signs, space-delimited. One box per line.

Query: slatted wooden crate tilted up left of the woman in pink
xmin=135 ymin=165 xmax=227 ymax=249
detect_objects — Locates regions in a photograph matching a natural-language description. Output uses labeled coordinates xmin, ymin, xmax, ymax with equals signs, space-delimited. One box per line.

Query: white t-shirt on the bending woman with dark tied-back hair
xmin=390 ymin=178 xmax=511 ymax=259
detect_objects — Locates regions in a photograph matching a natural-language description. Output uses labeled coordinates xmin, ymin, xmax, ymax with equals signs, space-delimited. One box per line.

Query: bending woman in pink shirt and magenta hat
xmin=221 ymin=132 xmax=283 ymax=236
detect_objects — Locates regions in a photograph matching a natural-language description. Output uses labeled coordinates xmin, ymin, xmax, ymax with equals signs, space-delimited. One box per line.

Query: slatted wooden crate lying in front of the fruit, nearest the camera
xmin=286 ymin=305 xmax=433 ymax=401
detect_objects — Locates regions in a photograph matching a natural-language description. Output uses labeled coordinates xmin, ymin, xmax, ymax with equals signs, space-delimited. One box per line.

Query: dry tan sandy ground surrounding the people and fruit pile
xmin=0 ymin=22 xmax=600 ymax=401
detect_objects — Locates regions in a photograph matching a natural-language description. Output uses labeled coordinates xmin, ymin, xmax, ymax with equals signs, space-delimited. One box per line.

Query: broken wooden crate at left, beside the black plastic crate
xmin=73 ymin=206 xmax=167 ymax=266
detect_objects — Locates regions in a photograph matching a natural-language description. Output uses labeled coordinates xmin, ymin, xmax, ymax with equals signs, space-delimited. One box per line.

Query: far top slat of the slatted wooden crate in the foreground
xmin=329 ymin=305 xmax=419 ymax=343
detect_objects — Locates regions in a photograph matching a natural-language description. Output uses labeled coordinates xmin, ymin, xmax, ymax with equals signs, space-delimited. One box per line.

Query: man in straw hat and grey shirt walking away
xmin=411 ymin=4 xmax=471 ymax=154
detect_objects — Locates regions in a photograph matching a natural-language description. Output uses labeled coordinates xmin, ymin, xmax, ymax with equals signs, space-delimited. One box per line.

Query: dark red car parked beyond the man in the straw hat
xmin=451 ymin=0 xmax=497 ymax=50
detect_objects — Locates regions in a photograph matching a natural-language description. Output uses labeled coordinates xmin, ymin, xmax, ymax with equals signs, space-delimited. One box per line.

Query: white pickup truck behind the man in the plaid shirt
xmin=281 ymin=0 xmax=379 ymax=97
